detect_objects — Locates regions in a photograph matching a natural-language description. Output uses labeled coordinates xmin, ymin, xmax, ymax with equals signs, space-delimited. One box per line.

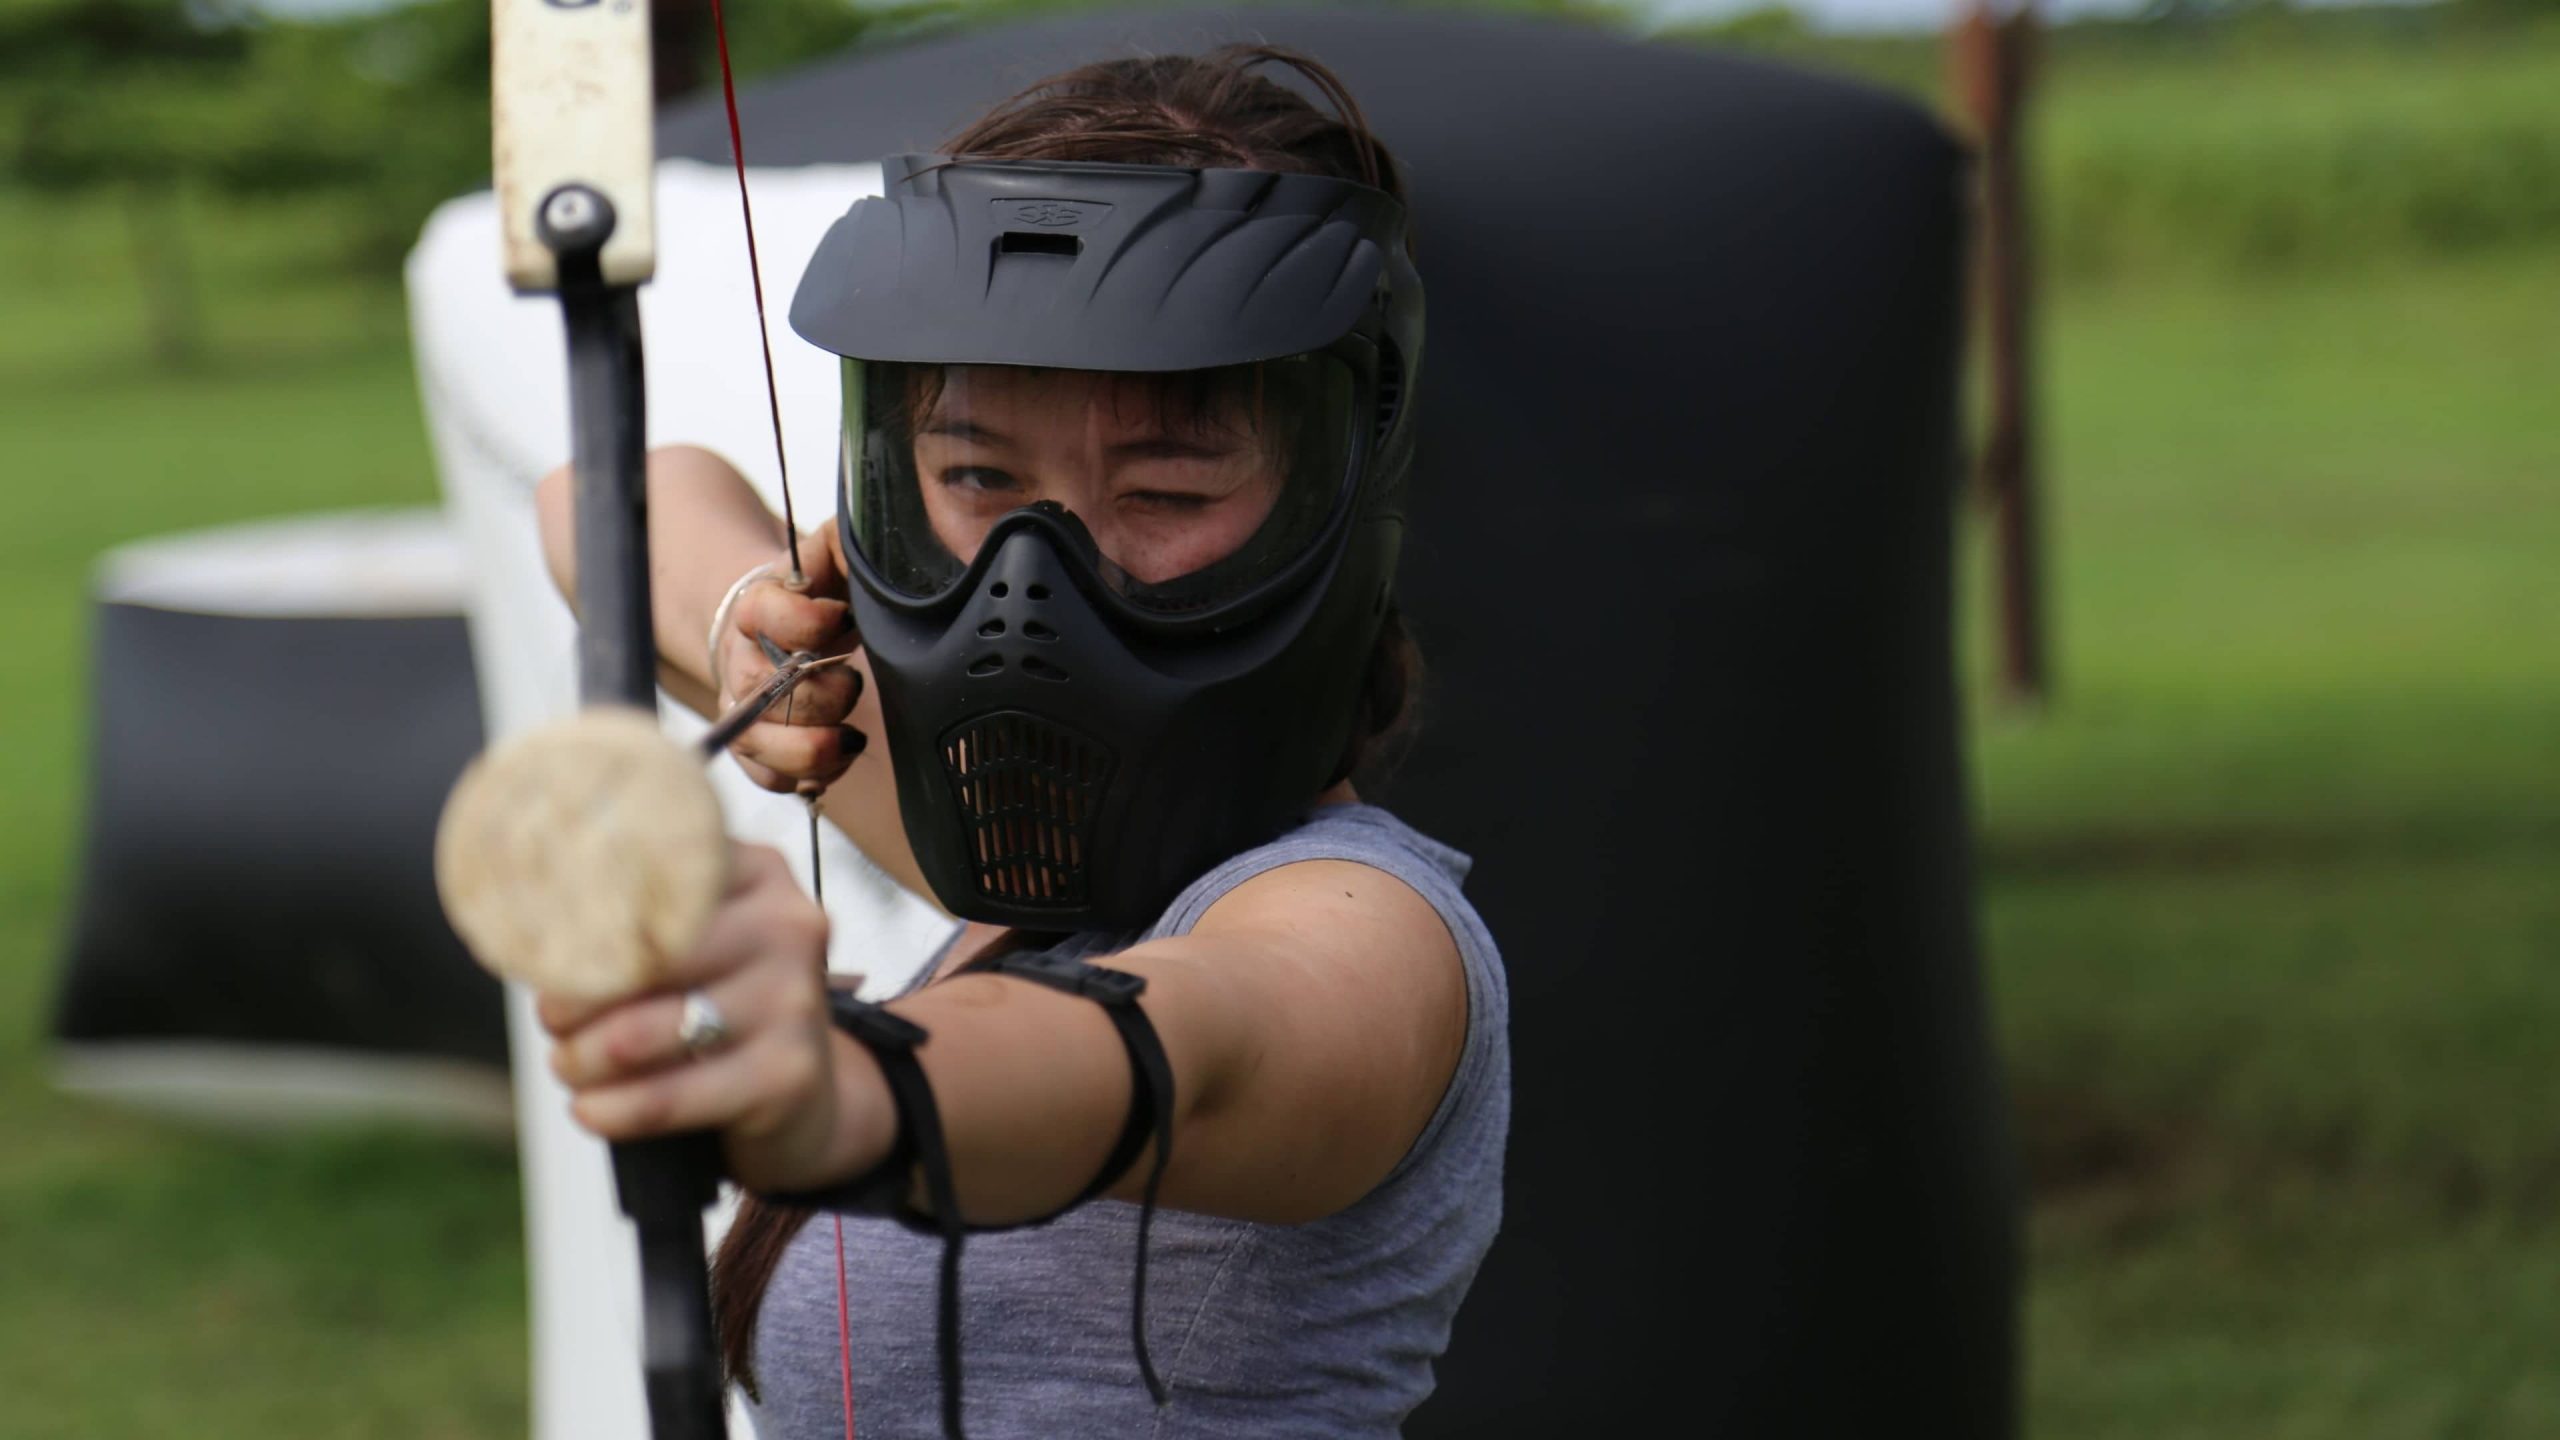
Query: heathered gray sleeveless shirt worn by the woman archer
xmin=750 ymin=805 xmax=1510 ymax=1440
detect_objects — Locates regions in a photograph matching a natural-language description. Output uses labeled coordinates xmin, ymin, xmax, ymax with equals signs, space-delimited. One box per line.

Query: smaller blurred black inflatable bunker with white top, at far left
xmin=54 ymin=512 xmax=515 ymax=1138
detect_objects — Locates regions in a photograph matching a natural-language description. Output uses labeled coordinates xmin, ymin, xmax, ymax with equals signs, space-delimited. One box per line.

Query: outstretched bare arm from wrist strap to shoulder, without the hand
xmin=896 ymin=861 xmax=1467 ymax=1222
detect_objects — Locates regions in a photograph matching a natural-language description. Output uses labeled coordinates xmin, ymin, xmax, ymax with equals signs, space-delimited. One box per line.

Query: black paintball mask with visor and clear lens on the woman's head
xmin=791 ymin=156 xmax=1423 ymax=930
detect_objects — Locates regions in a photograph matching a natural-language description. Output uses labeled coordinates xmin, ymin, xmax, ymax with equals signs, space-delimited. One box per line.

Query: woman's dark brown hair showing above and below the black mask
xmin=712 ymin=46 xmax=1421 ymax=1394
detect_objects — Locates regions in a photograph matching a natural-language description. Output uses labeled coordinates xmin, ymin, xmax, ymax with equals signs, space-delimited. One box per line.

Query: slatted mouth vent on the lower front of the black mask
xmin=942 ymin=710 xmax=1111 ymax=910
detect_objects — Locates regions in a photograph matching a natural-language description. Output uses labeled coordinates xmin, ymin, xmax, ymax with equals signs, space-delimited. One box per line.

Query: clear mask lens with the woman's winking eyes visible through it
xmin=842 ymin=356 xmax=1359 ymax=615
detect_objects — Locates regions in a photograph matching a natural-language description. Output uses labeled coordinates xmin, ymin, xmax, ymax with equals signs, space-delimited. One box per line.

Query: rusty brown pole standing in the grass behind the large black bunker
xmin=1948 ymin=0 xmax=2051 ymax=705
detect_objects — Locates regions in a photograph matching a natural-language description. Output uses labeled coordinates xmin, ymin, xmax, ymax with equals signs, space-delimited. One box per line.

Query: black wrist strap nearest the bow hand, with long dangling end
xmin=808 ymin=989 xmax=968 ymax=1440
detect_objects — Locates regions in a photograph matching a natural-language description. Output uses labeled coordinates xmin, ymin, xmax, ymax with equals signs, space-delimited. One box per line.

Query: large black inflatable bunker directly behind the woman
xmin=660 ymin=10 xmax=2017 ymax=1437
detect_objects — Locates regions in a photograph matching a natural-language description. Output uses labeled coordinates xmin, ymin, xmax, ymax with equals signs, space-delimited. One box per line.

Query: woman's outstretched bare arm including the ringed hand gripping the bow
xmin=545 ymin=845 xmax=1467 ymax=1222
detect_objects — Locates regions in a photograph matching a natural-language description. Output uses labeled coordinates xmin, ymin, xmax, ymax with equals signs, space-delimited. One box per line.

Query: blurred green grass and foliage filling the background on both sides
xmin=0 ymin=0 xmax=2560 ymax=1440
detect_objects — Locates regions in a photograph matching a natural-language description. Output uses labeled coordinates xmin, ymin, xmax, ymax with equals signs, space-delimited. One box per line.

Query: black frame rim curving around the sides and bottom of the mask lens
xmin=837 ymin=325 xmax=1388 ymax=638
